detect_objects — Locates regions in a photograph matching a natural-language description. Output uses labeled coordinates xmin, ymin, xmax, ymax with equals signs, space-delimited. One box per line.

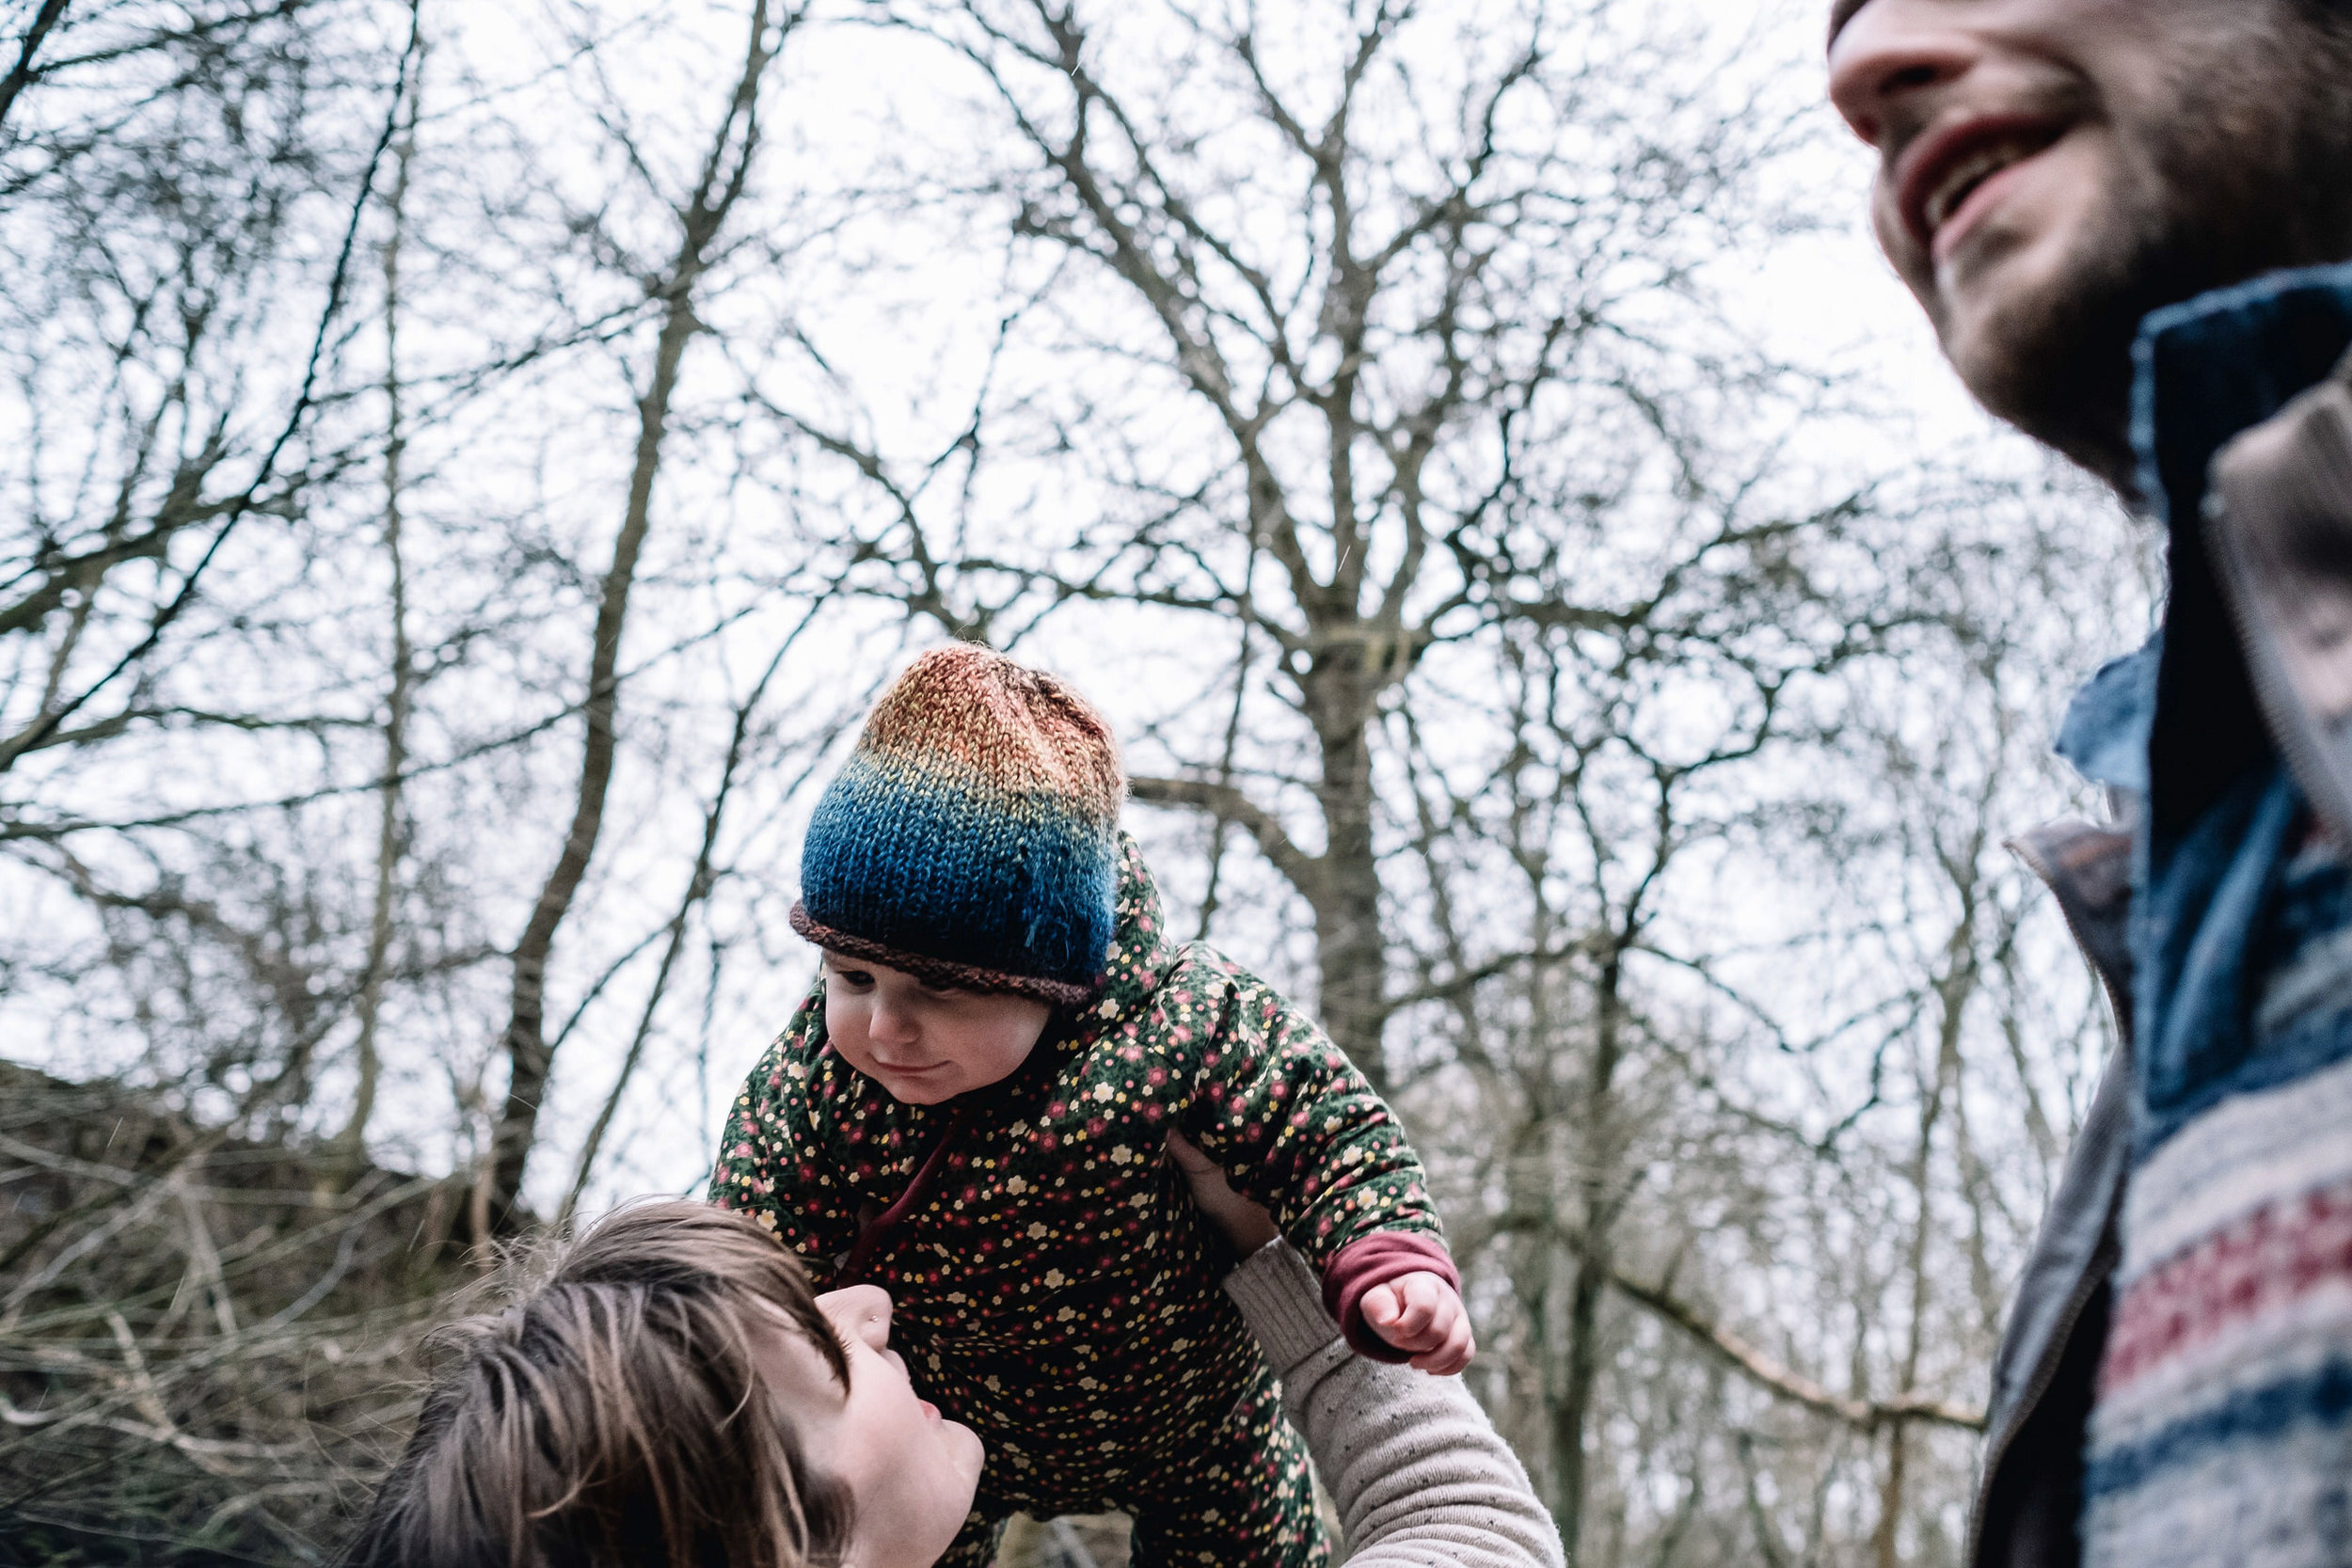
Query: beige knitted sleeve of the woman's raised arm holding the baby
xmin=1226 ymin=1242 xmax=1562 ymax=1568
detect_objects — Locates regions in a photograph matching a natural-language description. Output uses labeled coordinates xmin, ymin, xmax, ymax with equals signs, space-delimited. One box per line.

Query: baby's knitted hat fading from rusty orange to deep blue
xmin=793 ymin=641 xmax=1127 ymax=1006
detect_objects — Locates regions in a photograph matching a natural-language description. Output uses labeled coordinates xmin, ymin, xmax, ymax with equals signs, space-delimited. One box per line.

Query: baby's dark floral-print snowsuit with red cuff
xmin=710 ymin=839 xmax=1442 ymax=1568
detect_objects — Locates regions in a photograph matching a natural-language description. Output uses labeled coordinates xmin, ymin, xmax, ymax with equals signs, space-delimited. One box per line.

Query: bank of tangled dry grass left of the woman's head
xmin=0 ymin=1063 xmax=470 ymax=1563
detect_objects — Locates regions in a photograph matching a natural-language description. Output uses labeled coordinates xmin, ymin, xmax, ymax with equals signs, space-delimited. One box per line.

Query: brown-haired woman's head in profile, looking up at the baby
xmin=346 ymin=1204 xmax=981 ymax=1568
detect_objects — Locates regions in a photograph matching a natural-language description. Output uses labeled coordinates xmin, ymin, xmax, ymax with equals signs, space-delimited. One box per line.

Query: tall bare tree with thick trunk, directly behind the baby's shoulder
xmin=762 ymin=0 xmax=1842 ymax=1104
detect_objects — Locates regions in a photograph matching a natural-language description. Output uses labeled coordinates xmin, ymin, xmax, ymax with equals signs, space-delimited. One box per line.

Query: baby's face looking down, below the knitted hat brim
xmin=826 ymin=952 xmax=1054 ymax=1105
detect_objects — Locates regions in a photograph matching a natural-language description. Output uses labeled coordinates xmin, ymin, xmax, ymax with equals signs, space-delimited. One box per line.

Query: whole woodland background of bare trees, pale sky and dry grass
xmin=0 ymin=0 xmax=2153 ymax=1568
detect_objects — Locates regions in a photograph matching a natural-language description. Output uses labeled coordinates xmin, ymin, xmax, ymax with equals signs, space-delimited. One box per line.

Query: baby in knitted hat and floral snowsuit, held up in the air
xmin=710 ymin=646 xmax=1472 ymax=1568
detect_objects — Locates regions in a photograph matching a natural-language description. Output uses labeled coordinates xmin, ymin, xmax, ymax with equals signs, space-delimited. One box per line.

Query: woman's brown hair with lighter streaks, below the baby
xmin=343 ymin=1201 xmax=851 ymax=1568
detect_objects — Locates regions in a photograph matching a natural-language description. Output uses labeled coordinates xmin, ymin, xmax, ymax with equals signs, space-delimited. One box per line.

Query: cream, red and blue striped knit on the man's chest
xmin=2084 ymin=848 xmax=2352 ymax=1568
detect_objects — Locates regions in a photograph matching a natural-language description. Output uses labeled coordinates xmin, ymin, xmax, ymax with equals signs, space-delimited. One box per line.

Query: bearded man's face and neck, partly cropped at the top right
xmin=1830 ymin=0 xmax=2352 ymax=486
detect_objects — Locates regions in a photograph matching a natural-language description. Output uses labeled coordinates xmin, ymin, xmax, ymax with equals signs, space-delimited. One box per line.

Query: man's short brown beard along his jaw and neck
xmin=1964 ymin=2 xmax=2352 ymax=499
